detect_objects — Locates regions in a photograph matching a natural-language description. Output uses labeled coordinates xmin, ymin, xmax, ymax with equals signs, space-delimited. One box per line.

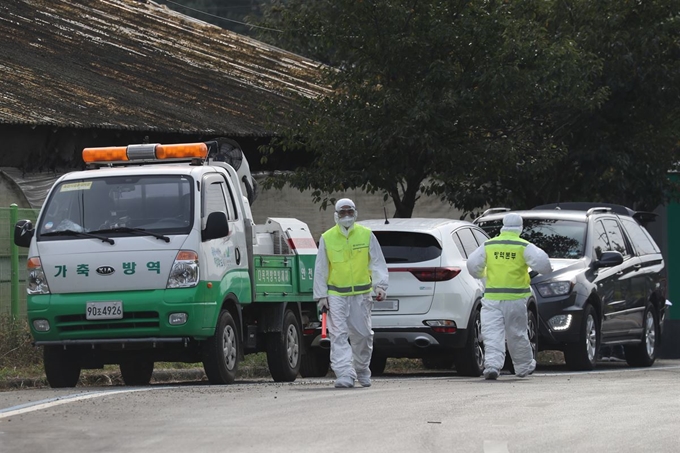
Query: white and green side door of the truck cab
xmin=201 ymin=173 xmax=249 ymax=299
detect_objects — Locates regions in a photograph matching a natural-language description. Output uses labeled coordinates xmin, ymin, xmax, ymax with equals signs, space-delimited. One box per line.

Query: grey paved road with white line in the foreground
xmin=0 ymin=361 xmax=680 ymax=453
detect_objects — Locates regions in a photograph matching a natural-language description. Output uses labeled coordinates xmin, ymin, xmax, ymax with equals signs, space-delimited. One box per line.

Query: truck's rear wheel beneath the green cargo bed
xmin=267 ymin=310 xmax=302 ymax=382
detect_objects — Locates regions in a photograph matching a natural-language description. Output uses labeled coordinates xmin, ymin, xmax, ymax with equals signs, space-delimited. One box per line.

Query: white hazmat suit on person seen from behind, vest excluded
xmin=467 ymin=213 xmax=552 ymax=380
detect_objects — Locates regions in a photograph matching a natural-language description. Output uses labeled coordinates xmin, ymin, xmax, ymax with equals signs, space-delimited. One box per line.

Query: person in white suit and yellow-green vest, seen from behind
xmin=467 ymin=213 xmax=552 ymax=380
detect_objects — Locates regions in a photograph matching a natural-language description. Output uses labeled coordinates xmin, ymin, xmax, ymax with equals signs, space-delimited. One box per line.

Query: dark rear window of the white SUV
xmin=373 ymin=231 xmax=442 ymax=263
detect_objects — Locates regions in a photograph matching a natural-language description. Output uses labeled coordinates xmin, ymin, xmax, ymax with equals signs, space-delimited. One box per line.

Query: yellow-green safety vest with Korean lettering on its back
xmin=484 ymin=231 xmax=531 ymax=300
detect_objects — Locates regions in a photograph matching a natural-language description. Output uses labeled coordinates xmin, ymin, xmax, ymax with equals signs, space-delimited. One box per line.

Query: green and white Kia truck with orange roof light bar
xmin=14 ymin=141 xmax=328 ymax=387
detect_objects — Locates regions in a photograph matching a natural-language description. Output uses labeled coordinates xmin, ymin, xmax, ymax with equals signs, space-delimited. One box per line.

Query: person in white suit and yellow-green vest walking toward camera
xmin=314 ymin=198 xmax=389 ymax=388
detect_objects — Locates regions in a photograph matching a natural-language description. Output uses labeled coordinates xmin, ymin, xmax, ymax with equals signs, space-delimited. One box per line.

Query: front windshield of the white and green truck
xmin=38 ymin=175 xmax=193 ymax=240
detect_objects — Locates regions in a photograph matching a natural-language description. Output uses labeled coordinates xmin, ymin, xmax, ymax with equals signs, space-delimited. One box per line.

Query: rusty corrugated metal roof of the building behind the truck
xmin=0 ymin=0 xmax=321 ymax=136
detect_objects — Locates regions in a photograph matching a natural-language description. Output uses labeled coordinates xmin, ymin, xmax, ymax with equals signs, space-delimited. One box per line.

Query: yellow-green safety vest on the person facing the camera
xmin=322 ymin=224 xmax=372 ymax=296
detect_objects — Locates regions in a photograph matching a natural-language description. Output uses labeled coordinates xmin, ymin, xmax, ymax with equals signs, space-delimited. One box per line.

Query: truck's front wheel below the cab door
xmin=203 ymin=310 xmax=241 ymax=385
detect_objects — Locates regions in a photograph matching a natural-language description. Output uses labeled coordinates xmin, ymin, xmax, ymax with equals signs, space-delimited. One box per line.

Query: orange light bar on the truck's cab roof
xmin=83 ymin=143 xmax=208 ymax=164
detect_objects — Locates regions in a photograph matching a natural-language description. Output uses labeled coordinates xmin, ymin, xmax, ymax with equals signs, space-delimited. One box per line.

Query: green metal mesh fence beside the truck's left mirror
xmin=0 ymin=204 xmax=39 ymax=317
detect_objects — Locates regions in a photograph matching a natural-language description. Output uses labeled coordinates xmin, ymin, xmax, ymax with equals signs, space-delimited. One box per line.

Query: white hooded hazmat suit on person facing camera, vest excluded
xmin=314 ymin=198 xmax=389 ymax=388
